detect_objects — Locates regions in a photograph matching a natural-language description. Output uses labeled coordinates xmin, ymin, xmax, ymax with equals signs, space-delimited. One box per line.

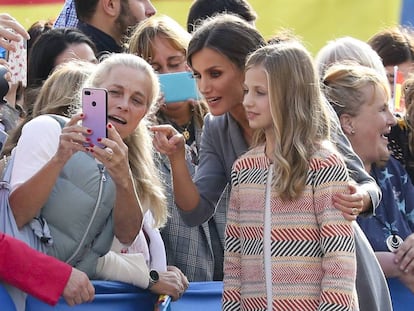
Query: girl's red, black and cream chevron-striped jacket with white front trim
xmin=223 ymin=146 xmax=358 ymax=311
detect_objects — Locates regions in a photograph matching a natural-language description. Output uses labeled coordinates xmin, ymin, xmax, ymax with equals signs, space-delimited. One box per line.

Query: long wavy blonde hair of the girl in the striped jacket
xmin=246 ymin=41 xmax=330 ymax=200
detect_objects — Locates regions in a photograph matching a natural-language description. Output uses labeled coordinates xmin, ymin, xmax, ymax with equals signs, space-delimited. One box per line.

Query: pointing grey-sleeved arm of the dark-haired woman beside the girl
xmin=153 ymin=115 xmax=230 ymax=226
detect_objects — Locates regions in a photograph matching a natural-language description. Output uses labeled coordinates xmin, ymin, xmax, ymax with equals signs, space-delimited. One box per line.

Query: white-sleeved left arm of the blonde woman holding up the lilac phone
xmin=10 ymin=115 xmax=86 ymax=227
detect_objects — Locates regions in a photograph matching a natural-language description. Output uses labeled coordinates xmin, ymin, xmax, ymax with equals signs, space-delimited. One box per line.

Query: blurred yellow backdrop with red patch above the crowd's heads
xmin=0 ymin=0 xmax=414 ymax=54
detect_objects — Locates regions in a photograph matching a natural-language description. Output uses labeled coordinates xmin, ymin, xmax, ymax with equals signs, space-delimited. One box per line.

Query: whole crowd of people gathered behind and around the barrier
xmin=0 ymin=0 xmax=414 ymax=311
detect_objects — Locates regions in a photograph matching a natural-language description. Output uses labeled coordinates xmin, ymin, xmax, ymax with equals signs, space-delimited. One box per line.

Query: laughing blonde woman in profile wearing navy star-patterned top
xmin=323 ymin=64 xmax=414 ymax=310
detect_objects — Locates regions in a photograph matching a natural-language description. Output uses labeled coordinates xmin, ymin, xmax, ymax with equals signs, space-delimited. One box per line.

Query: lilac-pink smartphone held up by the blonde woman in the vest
xmin=82 ymin=88 xmax=108 ymax=148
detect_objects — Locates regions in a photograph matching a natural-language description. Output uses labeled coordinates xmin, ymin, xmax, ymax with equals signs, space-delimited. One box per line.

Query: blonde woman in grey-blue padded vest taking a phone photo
xmin=10 ymin=54 xmax=188 ymax=299
